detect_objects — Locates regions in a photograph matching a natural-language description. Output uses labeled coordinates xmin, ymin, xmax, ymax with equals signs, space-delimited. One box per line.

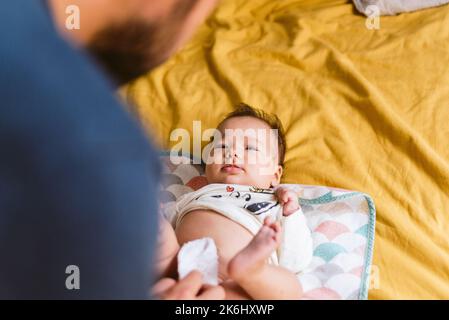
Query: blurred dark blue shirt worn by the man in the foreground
xmin=0 ymin=0 xmax=160 ymax=299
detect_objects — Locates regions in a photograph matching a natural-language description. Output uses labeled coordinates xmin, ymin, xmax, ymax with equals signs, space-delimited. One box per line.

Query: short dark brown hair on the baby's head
xmin=219 ymin=103 xmax=287 ymax=167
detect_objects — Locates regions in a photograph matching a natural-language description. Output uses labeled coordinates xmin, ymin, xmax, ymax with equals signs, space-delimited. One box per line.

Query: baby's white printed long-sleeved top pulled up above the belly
xmin=165 ymin=184 xmax=313 ymax=273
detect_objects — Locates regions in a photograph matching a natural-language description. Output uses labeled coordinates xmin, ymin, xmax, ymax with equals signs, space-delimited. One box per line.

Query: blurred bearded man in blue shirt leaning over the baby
xmin=0 ymin=0 xmax=220 ymax=299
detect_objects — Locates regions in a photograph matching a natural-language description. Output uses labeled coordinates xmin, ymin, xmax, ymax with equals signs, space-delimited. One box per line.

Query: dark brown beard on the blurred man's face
xmin=87 ymin=0 xmax=197 ymax=85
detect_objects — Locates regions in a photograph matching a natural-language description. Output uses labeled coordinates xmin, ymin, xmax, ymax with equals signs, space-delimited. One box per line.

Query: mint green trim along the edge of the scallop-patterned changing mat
xmin=159 ymin=151 xmax=376 ymax=300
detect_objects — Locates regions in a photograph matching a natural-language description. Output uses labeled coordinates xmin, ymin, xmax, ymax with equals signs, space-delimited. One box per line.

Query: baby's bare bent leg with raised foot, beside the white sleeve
xmin=228 ymin=219 xmax=302 ymax=300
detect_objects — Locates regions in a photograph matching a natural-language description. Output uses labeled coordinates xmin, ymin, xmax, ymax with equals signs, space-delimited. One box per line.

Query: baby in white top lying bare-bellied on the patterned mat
xmin=157 ymin=104 xmax=312 ymax=300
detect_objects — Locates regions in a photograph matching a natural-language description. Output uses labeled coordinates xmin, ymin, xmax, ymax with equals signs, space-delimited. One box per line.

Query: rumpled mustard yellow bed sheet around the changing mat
xmin=125 ymin=0 xmax=449 ymax=299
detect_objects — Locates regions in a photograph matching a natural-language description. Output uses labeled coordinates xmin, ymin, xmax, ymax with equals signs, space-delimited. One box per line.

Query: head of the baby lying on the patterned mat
xmin=206 ymin=104 xmax=286 ymax=189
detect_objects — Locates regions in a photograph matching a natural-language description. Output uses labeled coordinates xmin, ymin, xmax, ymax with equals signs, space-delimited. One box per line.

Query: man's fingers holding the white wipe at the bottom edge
xmin=152 ymin=271 xmax=225 ymax=300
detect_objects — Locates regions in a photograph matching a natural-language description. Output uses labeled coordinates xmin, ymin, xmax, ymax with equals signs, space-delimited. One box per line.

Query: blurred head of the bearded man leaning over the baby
xmin=47 ymin=0 xmax=218 ymax=84
